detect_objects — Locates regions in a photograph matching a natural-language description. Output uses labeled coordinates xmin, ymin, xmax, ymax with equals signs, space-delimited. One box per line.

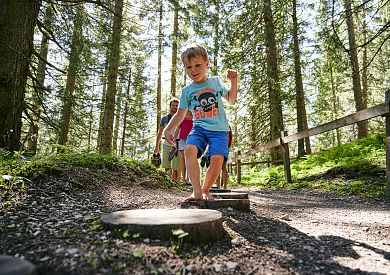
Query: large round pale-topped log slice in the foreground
xmin=101 ymin=209 xmax=224 ymax=243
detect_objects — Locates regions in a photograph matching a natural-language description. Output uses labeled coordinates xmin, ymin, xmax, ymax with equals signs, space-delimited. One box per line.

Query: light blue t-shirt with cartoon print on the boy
xmin=179 ymin=76 xmax=229 ymax=131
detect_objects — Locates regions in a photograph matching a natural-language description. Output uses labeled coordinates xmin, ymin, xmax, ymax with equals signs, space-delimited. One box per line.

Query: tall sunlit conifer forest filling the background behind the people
xmin=0 ymin=0 xmax=390 ymax=160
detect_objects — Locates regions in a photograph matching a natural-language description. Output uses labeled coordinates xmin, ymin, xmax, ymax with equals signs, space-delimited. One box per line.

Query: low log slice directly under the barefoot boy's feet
xmin=181 ymin=199 xmax=250 ymax=212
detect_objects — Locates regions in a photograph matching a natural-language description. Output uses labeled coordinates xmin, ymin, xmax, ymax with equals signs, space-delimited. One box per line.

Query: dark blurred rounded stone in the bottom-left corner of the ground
xmin=0 ymin=255 xmax=38 ymax=275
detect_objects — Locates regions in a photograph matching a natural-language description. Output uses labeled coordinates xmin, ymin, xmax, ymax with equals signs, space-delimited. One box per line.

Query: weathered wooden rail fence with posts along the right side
xmin=228 ymin=90 xmax=390 ymax=196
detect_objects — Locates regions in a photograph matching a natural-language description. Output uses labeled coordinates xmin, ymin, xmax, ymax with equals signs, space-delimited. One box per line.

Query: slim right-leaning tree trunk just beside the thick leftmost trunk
xmin=27 ymin=5 xmax=54 ymax=155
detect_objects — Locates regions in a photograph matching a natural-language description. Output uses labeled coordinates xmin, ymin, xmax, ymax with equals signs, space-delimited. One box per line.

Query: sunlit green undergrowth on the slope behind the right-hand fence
xmin=230 ymin=133 xmax=386 ymax=198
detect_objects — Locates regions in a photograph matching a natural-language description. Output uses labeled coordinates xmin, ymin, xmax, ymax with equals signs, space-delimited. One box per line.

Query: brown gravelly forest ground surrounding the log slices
xmin=0 ymin=167 xmax=390 ymax=275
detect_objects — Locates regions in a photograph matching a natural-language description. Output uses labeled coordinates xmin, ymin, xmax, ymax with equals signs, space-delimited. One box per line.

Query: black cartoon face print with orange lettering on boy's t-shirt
xmin=194 ymin=87 xmax=222 ymax=119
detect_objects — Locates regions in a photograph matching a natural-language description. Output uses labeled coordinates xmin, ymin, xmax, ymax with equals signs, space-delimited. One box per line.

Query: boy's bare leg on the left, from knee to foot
xmin=184 ymin=144 xmax=203 ymax=200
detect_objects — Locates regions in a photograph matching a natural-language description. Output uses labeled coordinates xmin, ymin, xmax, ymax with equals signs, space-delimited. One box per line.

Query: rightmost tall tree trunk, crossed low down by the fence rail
xmin=345 ymin=0 xmax=368 ymax=138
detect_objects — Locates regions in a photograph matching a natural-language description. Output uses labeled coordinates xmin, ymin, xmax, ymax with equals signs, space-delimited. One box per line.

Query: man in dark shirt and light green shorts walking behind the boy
xmin=154 ymin=99 xmax=179 ymax=181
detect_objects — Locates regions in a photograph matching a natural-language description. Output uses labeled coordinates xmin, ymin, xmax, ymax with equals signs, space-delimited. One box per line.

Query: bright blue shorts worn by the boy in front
xmin=187 ymin=125 xmax=229 ymax=163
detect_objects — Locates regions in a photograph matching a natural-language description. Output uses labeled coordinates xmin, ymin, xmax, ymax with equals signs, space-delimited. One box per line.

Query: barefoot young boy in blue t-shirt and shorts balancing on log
xmin=164 ymin=43 xmax=238 ymax=201
